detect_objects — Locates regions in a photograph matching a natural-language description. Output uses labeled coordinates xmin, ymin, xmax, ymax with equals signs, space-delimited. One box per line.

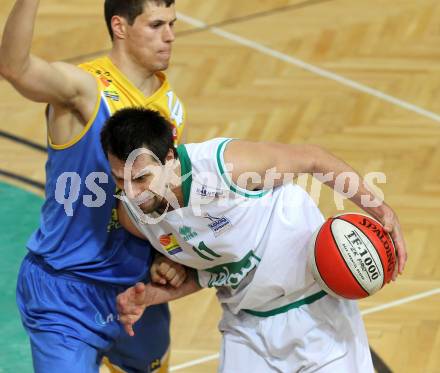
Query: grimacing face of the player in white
xmin=109 ymin=150 xmax=167 ymax=214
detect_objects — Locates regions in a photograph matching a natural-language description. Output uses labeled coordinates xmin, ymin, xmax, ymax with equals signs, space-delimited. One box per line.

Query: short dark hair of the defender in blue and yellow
xmin=104 ymin=0 xmax=174 ymax=40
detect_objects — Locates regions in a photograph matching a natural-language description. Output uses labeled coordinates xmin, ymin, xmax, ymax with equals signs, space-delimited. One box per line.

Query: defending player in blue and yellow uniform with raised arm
xmin=0 ymin=0 xmax=185 ymax=373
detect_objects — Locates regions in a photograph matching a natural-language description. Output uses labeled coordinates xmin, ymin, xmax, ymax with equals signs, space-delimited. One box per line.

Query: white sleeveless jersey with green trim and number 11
xmin=127 ymin=138 xmax=324 ymax=313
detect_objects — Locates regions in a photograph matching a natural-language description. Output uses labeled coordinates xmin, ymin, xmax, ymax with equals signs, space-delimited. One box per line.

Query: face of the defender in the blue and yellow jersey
xmin=126 ymin=1 xmax=176 ymax=72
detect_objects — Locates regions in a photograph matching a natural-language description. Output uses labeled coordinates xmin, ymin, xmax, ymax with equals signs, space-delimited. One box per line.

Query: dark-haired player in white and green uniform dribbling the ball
xmin=101 ymin=109 xmax=406 ymax=373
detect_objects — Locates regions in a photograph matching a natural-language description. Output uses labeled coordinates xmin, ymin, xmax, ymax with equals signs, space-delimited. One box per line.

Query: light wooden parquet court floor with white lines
xmin=0 ymin=0 xmax=440 ymax=373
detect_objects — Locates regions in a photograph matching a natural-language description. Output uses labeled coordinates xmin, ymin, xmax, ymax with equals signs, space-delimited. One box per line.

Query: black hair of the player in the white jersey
xmin=101 ymin=108 xmax=176 ymax=164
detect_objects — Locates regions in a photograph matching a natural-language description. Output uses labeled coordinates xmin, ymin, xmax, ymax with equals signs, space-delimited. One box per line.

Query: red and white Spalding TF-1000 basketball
xmin=309 ymin=213 xmax=396 ymax=299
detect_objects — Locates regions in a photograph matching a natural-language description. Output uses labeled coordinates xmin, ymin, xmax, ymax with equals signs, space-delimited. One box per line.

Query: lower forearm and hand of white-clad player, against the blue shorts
xmin=116 ymin=272 xmax=200 ymax=336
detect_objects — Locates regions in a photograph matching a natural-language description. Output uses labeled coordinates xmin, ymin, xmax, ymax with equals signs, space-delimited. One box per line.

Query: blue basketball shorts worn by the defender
xmin=17 ymin=254 xmax=170 ymax=373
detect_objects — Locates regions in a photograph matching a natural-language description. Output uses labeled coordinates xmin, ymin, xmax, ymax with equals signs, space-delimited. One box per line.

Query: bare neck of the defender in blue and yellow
xmin=109 ymin=49 xmax=161 ymax=97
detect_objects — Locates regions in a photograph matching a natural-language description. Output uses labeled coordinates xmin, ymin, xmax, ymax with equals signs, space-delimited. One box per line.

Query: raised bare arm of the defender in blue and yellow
xmin=0 ymin=0 xmax=97 ymax=109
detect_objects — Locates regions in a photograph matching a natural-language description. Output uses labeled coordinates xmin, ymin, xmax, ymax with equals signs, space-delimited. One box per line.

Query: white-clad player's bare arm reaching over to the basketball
xmin=224 ymin=140 xmax=407 ymax=279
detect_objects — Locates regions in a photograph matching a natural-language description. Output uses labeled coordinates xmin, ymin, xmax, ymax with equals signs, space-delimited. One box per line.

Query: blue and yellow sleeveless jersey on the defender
xmin=28 ymin=57 xmax=185 ymax=285
